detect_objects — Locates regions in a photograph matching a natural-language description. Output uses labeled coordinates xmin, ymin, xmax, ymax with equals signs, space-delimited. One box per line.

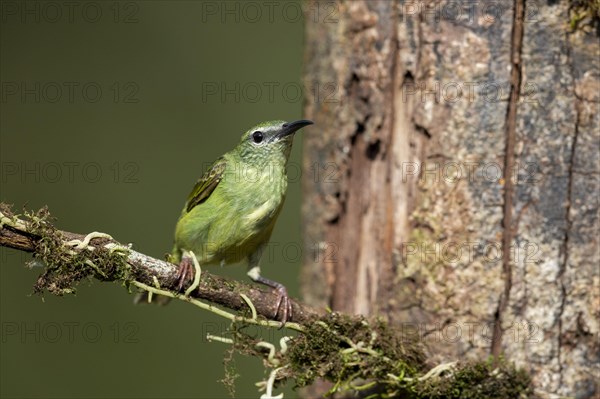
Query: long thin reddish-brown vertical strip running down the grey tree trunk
xmin=491 ymin=0 xmax=525 ymax=357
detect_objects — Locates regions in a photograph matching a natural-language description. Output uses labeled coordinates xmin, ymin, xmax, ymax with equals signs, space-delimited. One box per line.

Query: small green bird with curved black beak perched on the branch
xmin=170 ymin=120 xmax=313 ymax=325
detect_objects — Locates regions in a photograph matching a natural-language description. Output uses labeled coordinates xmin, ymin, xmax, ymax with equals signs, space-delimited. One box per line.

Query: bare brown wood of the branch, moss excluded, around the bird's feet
xmin=0 ymin=204 xmax=321 ymax=324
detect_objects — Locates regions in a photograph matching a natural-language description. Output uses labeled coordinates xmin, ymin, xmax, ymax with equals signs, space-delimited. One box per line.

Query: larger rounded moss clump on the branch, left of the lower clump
xmin=287 ymin=313 xmax=425 ymax=393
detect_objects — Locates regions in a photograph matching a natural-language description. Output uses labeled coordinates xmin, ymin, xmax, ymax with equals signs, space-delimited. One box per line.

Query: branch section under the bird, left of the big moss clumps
xmin=0 ymin=203 xmax=319 ymax=323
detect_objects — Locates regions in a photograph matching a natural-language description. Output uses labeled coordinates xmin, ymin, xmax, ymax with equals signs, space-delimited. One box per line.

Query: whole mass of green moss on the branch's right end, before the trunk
xmin=255 ymin=313 xmax=533 ymax=399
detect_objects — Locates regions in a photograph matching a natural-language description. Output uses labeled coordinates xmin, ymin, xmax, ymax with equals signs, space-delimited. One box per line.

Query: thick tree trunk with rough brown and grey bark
xmin=303 ymin=0 xmax=600 ymax=398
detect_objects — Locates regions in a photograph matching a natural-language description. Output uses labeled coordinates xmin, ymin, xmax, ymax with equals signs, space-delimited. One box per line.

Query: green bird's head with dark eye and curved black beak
xmin=237 ymin=119 xmax=313 ymax=164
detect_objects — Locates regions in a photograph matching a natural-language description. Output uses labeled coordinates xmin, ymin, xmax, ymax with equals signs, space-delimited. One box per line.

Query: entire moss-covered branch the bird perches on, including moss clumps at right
xmin=0 ymin=203 xmax=532 ymax=398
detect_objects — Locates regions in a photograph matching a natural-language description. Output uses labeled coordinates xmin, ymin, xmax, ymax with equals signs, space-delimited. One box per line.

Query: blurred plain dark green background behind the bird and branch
xmin=0 ymin=0 xmax=310 ymax=398
